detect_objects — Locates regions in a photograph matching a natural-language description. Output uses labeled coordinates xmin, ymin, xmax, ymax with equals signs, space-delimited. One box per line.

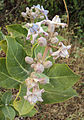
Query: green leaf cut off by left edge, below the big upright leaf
xmin=0 ymin=58 xmax=19 ymax=88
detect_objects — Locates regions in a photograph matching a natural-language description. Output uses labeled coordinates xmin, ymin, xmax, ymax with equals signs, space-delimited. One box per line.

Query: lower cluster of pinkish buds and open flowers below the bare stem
xmin=24 ymin=53 xmax=52 ymax=104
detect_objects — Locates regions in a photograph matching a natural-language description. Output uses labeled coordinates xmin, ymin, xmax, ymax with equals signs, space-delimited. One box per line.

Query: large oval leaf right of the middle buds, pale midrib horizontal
xmin=47 ymin=64 xmax=79 ymax=91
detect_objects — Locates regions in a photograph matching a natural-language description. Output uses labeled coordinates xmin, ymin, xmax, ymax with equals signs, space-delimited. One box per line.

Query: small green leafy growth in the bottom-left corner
xmin=0 ymin=92 xmax=16 ymax=120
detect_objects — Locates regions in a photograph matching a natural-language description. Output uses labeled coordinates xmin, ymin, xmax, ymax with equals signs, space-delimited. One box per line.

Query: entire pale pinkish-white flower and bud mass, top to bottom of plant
xmin=22 ymin=5 xmax=71 ymax=104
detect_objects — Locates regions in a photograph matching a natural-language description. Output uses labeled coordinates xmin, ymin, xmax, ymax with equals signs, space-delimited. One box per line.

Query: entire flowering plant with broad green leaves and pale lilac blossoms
xmin=0 ymin=5 xmax=79 ymax=120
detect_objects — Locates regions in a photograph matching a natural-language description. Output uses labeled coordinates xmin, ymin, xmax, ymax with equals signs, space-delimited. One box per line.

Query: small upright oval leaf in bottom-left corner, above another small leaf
xmin=1 ymin=92 xmax=12 ymax=105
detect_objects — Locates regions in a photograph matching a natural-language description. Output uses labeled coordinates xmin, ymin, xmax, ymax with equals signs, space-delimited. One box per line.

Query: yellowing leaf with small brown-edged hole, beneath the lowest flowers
xmin=13 ymin=85 xmax=34 ymax=116
